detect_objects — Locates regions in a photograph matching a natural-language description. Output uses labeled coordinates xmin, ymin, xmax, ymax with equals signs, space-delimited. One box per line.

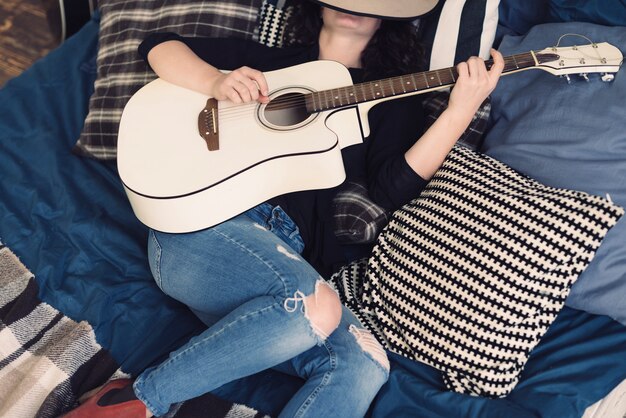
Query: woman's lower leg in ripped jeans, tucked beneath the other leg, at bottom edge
xmin=274 ymin=307 xmax=389 ymax=418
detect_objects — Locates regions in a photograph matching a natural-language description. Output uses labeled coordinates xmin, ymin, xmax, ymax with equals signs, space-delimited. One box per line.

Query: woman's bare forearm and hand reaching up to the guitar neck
xmin=405 ymin=49 xmax=504 ymax=180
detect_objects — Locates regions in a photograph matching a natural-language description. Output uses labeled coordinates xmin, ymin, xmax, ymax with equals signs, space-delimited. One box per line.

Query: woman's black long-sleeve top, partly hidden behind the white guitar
xmin=139 ymin=33 xmax=426 ymax=276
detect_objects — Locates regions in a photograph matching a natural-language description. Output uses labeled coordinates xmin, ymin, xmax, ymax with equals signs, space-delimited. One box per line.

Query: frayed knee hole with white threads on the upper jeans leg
xmin=284 ymin=279 xmax=341 ymax=340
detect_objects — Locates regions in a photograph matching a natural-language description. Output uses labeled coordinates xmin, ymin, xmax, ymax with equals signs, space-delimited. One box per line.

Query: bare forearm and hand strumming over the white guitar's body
xmin=148 ymin=40 xmax=269 ymax=103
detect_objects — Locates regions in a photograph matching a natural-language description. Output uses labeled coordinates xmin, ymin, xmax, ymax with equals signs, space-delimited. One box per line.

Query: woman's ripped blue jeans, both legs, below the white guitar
xmin=134 ymin=203 xmax=389 ymax=418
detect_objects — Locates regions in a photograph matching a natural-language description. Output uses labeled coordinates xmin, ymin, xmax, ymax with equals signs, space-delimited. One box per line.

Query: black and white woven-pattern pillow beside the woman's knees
xmin=332 ymin=146 xmax=624 ymax=397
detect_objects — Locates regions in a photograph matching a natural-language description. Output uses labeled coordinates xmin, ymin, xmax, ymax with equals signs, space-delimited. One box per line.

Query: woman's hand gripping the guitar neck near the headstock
xmin=448 ymin=48 xmax=504 ymax=120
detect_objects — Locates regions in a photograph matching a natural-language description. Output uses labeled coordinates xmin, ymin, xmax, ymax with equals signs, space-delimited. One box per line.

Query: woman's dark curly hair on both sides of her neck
xmin=283 ymin=0 xmax=424 ymax=79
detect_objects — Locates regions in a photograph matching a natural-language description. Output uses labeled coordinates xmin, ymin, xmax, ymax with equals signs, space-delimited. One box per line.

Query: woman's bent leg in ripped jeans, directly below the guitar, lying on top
xmin=134 ymin=204 xmax=341 ymax=415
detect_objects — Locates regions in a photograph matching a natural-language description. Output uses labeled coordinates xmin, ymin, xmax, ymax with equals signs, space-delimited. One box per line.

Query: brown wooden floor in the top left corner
xmin=0 ymin=0 xmax=57 ymax=87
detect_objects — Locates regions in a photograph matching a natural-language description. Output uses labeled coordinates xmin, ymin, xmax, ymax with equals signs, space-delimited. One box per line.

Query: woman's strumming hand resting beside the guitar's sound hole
xmin=210 ymin=67 xmax=269 ymax=103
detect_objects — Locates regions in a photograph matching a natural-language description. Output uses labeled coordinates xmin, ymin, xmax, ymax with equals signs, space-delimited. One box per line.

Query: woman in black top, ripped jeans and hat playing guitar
xmin=63 ymin=0 xmax=504 ymax=418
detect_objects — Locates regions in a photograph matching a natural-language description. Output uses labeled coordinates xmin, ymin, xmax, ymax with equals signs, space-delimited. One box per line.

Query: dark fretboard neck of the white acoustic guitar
xmin=305 ymin=52 xmax=559 ymax=113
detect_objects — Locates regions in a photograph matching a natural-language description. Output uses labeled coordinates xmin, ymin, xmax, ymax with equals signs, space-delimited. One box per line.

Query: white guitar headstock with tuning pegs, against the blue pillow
xmin=532 ymin=42 xmax=624 ymax=81
